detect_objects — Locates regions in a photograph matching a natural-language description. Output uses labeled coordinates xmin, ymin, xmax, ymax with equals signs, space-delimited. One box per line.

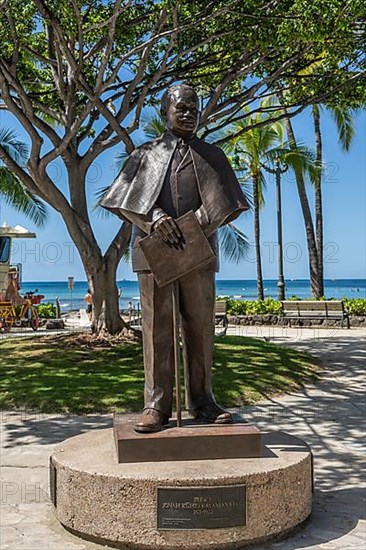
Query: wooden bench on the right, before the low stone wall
xmin=281 ymin=300 xmax=350 ymax=328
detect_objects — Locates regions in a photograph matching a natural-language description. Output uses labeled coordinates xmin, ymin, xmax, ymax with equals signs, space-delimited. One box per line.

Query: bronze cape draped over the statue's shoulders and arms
xmin=101 ymin=132 xmax=249 ymax=227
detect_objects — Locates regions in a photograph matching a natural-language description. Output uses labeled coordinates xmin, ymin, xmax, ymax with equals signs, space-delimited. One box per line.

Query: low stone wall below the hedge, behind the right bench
xmin=228 ymin=314 xmax=366 ymax=327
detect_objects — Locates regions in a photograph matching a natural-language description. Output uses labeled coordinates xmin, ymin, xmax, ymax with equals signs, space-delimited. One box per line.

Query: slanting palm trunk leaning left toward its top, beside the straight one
xmin=285 ymin=118 xmax=322 ymax=298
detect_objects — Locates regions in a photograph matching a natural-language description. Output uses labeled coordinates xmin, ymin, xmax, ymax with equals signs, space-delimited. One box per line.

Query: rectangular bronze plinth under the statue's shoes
xmin=113 ymin=421 xmax=261 ymax=463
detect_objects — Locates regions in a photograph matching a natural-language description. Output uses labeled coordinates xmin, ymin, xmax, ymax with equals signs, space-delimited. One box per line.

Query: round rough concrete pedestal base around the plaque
xmin=51 ymin=429 xmax=312 ymax=550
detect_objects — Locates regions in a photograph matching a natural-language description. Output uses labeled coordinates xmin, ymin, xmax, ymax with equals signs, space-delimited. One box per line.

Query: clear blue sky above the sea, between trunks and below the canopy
xmin=0 ymin=106 xmax=366 ymax=281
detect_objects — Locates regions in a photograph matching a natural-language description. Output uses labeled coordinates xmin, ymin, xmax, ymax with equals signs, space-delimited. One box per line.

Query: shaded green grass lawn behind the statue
xmin=0 ymin=336 xmax=318 ymax=414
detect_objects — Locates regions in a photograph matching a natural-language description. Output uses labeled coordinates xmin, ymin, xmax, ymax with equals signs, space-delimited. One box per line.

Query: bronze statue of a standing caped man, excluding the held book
xmin=102 ymin=84 xmax=249 ymax=432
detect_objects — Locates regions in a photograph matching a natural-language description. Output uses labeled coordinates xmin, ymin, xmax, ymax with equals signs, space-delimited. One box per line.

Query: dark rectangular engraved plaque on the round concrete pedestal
xmin=157 ymin=485 xmax=246 ymax=529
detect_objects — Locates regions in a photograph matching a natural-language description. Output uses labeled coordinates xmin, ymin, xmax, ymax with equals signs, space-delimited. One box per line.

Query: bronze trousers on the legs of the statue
xmin=138 ymin=269 xmax=215 ymax=417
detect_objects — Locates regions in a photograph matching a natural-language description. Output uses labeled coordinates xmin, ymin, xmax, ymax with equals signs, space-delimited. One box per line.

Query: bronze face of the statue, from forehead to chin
xmin=166 ymin=88 xmax=200 ymax=138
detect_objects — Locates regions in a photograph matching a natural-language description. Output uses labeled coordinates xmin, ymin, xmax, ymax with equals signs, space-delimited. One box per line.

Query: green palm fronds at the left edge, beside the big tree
xmin=0 ymin=128 xmax=47 ymax=227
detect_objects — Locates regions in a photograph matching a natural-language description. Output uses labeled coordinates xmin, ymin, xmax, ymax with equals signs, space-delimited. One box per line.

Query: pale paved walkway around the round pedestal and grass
xmin=0 ymin=327 xmax=366 ymax=550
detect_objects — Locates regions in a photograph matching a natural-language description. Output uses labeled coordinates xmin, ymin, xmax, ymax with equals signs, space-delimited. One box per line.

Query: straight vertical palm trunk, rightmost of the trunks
xmin=313 ymin=105 xmax=324 ymax=298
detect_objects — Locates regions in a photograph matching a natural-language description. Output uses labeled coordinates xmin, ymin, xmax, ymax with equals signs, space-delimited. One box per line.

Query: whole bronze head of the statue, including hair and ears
xmin=160 ymin=84 xmax=200 ymax=139
